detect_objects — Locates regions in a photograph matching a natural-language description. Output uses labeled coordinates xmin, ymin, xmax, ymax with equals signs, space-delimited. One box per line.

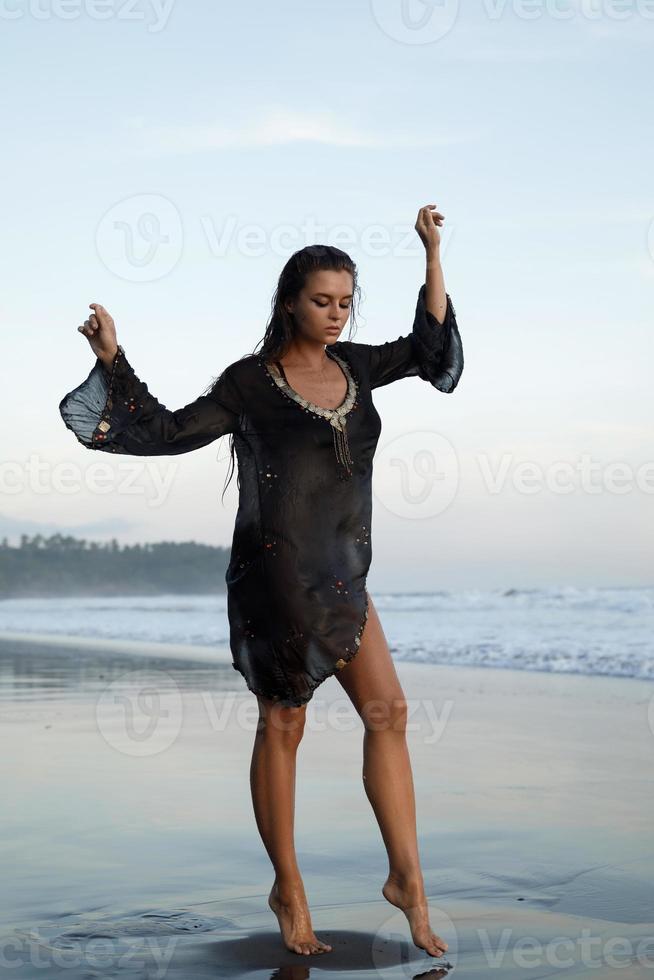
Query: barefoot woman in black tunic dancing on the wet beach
xmin=59 ymin=204 xmax=463 ymax=956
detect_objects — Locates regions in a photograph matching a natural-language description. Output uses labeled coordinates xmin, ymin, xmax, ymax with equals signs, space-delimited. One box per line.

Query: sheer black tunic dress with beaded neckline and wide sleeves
xmin=59 ymin=284 xmax=463 ymax=706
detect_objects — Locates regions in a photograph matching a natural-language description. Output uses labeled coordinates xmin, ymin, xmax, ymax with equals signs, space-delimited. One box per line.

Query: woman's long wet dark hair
xmin=205 ymin=245 xmax=361 ymax=506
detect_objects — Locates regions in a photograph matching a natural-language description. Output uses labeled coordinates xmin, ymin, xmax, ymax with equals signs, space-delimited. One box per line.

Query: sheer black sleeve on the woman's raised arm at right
xmin=344 ymin=283 xmax=463 ymax=393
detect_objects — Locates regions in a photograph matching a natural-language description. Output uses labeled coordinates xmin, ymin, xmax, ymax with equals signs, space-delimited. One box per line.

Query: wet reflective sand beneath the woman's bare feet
xmin=0 ymin=635 xmax=654 ymax=980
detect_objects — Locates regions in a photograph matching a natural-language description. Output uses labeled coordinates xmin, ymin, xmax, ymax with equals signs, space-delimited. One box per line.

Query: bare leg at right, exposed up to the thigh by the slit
xmin=336 ymin=599 xmax=448 ymax=956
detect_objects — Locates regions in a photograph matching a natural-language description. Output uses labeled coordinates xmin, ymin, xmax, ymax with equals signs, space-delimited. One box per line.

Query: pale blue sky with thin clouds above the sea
xmin=0 ymin=0 xmax=654 ymax=594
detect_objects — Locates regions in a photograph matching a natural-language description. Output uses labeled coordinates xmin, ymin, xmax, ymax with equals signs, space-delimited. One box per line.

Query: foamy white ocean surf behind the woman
xmin=0 ymin=586 xmax=654 ymax=680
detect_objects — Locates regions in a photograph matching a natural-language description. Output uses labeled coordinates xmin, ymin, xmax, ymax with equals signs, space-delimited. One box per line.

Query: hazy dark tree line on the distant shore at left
xmin=0 ymin=534 xmax=230 ymax=598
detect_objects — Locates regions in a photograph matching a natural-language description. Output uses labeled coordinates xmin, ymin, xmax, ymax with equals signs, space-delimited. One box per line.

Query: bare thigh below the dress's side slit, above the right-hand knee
xmin=335 ymin=594 xmax=404 ymax=714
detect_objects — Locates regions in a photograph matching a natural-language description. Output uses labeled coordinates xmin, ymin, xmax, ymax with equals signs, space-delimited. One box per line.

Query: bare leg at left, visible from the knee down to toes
xmin=250 ymin=695 xmax=332 ymax=955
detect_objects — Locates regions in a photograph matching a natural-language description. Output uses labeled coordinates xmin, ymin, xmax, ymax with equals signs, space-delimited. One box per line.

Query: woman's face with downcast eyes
xmin=286 ymin=269 xmax=352 ymax=345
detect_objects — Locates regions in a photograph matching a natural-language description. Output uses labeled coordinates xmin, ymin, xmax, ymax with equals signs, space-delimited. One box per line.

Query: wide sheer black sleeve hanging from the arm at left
xmin=59 ymin=345 xmax=241 ymax=456
